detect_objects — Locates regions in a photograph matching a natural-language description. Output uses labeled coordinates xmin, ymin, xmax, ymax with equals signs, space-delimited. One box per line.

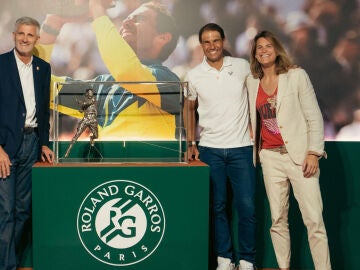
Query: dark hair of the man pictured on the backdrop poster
xmin=143 ymin=2 xmax=179 ymax=61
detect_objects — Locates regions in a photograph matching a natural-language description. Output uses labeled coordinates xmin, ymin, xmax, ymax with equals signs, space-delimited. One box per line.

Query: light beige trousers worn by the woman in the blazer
xmin=260 ymin=149 xmax=331 ymax=270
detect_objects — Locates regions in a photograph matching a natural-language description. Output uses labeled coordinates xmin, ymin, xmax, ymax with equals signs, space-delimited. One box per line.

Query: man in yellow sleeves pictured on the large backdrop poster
xmin=39 ymin=0 xmax=180 ymax=140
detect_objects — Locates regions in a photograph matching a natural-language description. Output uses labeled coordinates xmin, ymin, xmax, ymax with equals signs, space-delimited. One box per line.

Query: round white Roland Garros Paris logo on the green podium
xmin=77 ymin=180 xmax=165 ymax=266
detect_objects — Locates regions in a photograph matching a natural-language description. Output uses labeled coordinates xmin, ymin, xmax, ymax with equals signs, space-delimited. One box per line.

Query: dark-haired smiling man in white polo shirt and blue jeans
xmin=184 ymin=23 xmax=255 ymax=270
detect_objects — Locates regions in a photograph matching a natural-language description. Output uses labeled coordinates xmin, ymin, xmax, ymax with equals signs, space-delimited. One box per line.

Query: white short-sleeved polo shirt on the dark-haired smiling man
xmin=184 ymin=56 xmax=252 ymax=148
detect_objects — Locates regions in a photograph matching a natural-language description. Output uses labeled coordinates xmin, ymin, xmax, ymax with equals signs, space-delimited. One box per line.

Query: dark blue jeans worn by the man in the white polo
xmin=199 ymin=146 xmax=256 ymax=263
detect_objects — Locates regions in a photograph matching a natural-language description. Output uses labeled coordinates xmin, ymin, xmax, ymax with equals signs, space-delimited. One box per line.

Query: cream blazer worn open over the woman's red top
xmin=246 ymin=68 xmax=326 ymax=165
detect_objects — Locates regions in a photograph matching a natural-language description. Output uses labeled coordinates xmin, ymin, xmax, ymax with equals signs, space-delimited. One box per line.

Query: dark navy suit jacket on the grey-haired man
xmin=0 ymin=50 xmax=51 ymax=159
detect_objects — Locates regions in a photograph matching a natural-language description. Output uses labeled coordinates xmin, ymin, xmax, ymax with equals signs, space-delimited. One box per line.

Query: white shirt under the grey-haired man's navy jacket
xmin=14 ymin=50 xmax=37 ymax=127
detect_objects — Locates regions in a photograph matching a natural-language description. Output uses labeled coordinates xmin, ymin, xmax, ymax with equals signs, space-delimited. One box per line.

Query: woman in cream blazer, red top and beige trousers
xmin=246 ymin=31 xmax=331 ymax=270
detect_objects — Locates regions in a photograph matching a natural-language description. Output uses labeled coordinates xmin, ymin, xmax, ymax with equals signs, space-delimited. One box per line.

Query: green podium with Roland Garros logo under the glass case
xmin=33 ymin=162 xmax=209 ymax=270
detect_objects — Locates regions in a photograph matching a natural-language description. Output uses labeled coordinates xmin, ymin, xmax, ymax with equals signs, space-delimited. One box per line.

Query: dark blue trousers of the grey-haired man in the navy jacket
xmin=0 ymin=132 xmax=39 ymax=270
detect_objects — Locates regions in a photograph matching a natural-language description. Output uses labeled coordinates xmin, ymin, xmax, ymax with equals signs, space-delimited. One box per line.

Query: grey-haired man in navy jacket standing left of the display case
xmin=0 ymin=17 xmax=54 ymax=270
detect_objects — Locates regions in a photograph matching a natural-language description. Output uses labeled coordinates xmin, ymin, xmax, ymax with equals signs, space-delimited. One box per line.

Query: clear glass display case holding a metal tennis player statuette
xmin=50 ymin=81 xmax=188 ymax=163
